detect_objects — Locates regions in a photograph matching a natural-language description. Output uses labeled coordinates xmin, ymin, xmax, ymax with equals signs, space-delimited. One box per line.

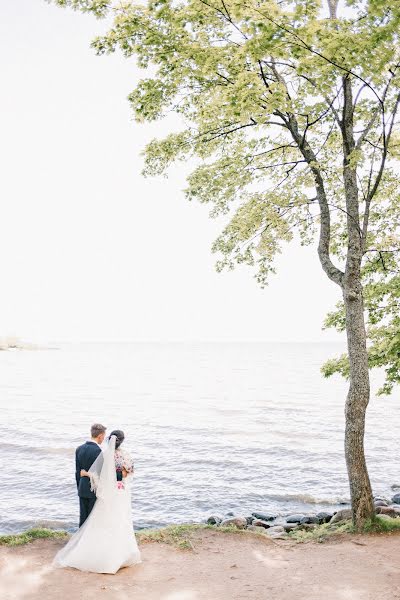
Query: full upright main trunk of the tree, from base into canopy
xmin=341 ymin=75 xmax=375 ymax=530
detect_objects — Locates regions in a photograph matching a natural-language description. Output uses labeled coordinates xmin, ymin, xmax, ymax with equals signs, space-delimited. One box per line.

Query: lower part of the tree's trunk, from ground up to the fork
xmin=343 ymin=281 xmax=375 ymax=530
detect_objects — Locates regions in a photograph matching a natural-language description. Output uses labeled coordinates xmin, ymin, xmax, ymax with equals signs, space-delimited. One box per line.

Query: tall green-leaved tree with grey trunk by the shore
xmin=54 ymin=0 xmax=400 ymax=528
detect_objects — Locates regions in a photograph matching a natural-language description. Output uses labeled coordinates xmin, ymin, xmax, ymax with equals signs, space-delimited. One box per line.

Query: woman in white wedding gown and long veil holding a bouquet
xmin=53 ymin=430 xmax=141 ymax=574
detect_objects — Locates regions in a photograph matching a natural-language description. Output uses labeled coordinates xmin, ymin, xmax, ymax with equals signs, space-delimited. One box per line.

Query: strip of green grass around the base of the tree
xmin=288 ymin=515 xmax=400 ymax=543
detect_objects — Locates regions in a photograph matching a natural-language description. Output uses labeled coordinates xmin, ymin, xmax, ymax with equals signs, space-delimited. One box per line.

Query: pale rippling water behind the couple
xmin=0 ymin=343 xmax=400 ymax=533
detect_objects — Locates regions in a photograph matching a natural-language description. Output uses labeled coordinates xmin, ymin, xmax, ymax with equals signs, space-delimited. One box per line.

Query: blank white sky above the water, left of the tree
xmin=0 ymin=0 xmax=342 ymax=343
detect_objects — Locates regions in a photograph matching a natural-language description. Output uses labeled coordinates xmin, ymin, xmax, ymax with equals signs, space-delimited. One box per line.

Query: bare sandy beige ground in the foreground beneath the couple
xmin=0 ymin=530 xmax=400 ymax=600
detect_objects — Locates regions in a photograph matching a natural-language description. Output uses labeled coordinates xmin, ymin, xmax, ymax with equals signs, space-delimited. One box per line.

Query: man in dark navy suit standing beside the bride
xmin=75 ymin=423 xmax=107 ymax=527
